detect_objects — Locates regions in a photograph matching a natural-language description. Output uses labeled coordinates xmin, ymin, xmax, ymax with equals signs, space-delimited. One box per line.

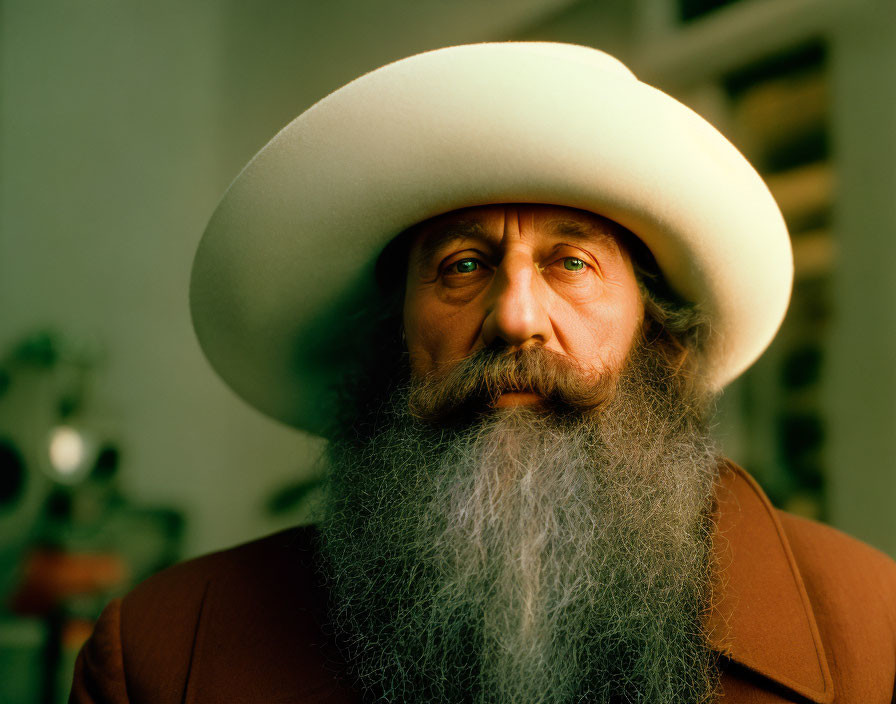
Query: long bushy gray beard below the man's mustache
xmin=322 ymin=350 xmax=718 ymax=704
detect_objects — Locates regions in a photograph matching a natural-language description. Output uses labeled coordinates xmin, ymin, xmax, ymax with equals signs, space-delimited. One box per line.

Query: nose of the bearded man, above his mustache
xmin=482 ymin=252 xmax=552 ymax=347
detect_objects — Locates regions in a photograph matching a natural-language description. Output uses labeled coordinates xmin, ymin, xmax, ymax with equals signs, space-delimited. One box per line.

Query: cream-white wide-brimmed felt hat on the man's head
xmin=190 ymin=42 xmax=793 ymax=432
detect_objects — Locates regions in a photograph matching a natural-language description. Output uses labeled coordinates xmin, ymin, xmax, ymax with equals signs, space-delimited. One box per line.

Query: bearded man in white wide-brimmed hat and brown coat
xmin=72 ymin=43 xmax=896 ymax=704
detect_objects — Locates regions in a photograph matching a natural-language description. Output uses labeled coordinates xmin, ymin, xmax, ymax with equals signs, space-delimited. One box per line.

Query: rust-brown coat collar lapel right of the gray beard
xmin=709 ymin=462 xmax=834 ymax=704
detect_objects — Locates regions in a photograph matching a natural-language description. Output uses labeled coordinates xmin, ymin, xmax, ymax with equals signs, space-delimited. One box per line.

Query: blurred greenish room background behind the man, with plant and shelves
xmin=0 ymin=0 xmax=896 ymax=703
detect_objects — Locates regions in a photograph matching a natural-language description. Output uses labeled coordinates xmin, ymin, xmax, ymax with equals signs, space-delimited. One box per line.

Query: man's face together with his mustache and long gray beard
xmin=322 ymin=205 xmax=717 ymax=704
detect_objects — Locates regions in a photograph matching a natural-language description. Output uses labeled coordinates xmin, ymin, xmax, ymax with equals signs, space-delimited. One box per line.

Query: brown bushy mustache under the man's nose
xmin=408 ymin=345 xmax=620 ymax=423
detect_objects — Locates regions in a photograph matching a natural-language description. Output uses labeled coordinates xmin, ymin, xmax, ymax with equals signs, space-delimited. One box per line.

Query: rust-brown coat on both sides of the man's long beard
xmin=70 ymin=466 xmax=896 ymax=704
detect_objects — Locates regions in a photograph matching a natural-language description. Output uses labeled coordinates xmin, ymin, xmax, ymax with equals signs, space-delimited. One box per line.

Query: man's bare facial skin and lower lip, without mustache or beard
xmin=404 ymin=205 xmax=644 ymax=406
